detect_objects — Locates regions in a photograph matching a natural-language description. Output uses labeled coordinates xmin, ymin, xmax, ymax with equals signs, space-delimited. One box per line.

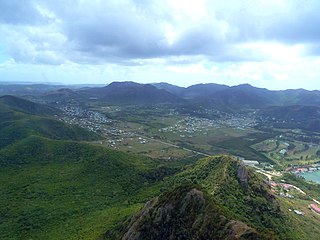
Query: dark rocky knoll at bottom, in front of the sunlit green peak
xmin=109 ymin=186 xmax=263 ymax=240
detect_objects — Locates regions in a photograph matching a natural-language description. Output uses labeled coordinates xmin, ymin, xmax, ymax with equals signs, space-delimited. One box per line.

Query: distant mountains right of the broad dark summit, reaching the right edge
xmin=155 ymin=83 xmax=320 ymax=111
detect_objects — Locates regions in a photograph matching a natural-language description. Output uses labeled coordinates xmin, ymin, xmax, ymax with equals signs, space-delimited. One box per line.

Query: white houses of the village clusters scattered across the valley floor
xmin=59 ymin=104 xmax=257 ymax=148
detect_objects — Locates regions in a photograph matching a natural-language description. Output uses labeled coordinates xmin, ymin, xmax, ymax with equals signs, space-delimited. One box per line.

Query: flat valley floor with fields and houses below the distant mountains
xmin=60 ymin=104 xmax=320 ymax=168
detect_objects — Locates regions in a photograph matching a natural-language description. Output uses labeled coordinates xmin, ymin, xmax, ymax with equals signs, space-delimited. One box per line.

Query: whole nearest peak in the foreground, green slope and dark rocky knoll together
xmin=105 ymin=156 xmax=297 ymax=240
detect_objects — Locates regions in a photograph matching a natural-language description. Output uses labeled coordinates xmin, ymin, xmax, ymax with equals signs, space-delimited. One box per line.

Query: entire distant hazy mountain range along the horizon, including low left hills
xmin=0 ymin=82 xmax=320 ymax=111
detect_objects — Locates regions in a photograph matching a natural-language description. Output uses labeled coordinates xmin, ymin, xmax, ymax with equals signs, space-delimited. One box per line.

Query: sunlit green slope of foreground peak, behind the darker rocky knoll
xmin=172 ymin=156 xmax=291 ymax=236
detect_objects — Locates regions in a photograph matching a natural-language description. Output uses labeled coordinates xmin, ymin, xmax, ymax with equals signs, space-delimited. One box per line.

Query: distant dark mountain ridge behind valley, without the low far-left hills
xmin=76 ymin=82 xmax=320 ymax=110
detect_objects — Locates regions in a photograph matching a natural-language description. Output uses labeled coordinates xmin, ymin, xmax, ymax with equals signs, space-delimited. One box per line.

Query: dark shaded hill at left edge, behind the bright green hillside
xmin=0 ymin=96 xmax=98 ymax=149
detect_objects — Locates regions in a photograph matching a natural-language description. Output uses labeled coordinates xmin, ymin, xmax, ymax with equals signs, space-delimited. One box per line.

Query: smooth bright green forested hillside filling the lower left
xmin=0 ymin=136 xmax=169 ymax=239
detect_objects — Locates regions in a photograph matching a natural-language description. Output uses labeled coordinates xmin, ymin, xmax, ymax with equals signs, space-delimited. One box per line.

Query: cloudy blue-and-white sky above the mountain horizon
xmin=0 ymin=0 xmax=320 ymax=90
